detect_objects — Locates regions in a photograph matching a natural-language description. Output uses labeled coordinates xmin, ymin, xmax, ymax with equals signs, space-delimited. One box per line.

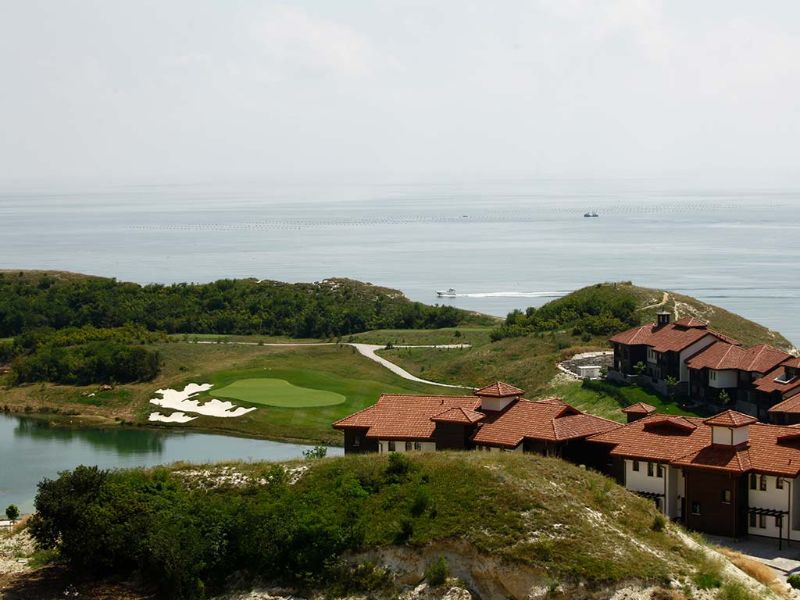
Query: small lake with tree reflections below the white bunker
xmin=0 ymin=415 xmax=343 ymax=515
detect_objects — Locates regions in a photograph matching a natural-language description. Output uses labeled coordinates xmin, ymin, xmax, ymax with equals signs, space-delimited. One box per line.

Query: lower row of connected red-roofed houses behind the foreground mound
xmin=333 ymin=382 xmax=800 ymax=540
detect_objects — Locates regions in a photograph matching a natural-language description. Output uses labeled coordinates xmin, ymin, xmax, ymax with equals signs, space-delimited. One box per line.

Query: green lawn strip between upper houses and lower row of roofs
xmin=542 ymin=381 xmax=704 ymax=422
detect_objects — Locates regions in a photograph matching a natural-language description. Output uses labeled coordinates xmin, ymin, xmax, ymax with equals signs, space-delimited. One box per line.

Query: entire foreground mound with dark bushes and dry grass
xmin=23 ymin=453 xmax=756 ymax=598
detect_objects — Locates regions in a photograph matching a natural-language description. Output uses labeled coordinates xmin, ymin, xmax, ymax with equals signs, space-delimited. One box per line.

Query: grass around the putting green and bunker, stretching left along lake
xmin=0 ymin=343 xmax=466 ymax=443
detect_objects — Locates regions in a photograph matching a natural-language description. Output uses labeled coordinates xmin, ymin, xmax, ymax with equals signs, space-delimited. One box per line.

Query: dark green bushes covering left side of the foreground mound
xmin=29 ymin=455 xmax=428 ymax=598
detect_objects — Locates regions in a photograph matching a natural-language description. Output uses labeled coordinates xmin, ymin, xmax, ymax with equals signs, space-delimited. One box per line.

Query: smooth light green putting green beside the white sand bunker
xmin=210 ymin=378 xmax=347 ymax=408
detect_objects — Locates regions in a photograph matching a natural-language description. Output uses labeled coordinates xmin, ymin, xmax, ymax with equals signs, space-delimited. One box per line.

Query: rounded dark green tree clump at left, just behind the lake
xmin=0 ymin=326 xmax=164 ymax=385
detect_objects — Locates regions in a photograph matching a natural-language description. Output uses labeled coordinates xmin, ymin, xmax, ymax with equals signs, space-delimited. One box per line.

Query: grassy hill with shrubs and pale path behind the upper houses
xmin=382 ymin=283 xmax=792 ymax=408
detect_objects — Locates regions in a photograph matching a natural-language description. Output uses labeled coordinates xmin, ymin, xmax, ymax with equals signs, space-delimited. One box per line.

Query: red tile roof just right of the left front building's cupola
xmin=472 ymin=399 xmax=620 ymax=448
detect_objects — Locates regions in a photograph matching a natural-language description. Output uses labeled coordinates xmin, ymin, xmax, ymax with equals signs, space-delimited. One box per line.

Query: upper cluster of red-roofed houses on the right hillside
xmin=609 ymin=313 xmax=800 ymax=424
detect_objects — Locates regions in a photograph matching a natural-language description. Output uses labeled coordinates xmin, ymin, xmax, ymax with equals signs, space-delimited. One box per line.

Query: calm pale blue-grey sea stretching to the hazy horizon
xmin=0 ymin=180 xmax=800 ymax=342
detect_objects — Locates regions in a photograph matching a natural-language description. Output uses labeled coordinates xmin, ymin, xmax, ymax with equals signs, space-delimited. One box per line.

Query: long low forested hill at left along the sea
xmin=0 ymin=271 xmax=482 ymax=338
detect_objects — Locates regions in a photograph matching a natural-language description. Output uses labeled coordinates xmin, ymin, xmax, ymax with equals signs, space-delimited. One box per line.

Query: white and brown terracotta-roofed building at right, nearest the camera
xmin=589 ymin=410 xmax=800 ymax=540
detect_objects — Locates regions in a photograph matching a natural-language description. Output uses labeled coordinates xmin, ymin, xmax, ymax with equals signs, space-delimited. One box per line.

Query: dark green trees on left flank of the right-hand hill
xmin=492 ymin=284 xmax=639 ymax=340
